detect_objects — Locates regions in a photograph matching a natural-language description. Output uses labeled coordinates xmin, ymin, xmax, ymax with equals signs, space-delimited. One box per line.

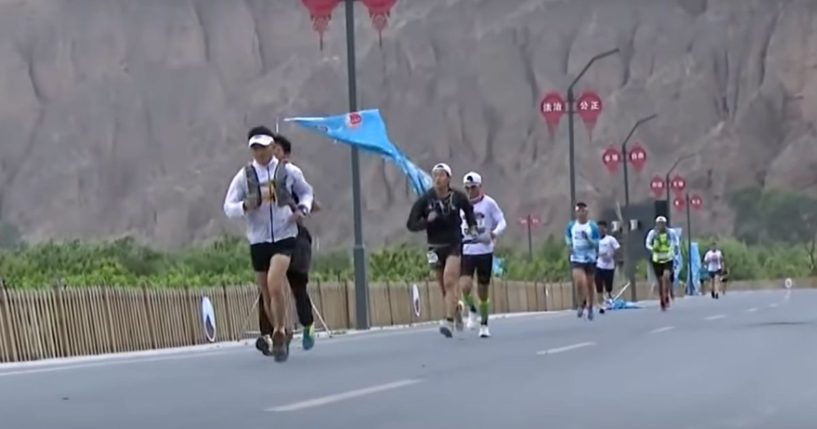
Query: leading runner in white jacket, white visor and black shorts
xmin=224 ymin=127 xmax=313 ymax=362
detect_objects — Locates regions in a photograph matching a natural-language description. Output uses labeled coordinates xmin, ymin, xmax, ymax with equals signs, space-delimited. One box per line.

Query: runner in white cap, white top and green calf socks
xmin=460 ymin=171 xmax=507 ymax=338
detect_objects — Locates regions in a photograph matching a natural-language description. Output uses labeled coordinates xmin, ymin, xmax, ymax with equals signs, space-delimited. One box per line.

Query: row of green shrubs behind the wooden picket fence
xmin=0 ymin=232 xmax=810 ymax=288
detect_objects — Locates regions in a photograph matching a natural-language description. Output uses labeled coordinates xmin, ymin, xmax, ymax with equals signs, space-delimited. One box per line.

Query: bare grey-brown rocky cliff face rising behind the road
xmin=0 ymin=0 xmax=817 ymax=246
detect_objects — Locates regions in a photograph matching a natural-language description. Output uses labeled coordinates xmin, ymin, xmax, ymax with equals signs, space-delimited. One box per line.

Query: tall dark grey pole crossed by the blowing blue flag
xmin=345 ymin=0 xmax=369 ymax=330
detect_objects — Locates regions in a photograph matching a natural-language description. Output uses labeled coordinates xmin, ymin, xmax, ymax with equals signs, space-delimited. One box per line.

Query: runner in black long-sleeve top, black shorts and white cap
xmin=406 ymin=163 xmax=477 ymax=338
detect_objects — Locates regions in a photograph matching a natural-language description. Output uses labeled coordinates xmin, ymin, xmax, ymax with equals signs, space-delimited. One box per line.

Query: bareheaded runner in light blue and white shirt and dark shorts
xmin=565 ymin=202 xmax=601 ymax=320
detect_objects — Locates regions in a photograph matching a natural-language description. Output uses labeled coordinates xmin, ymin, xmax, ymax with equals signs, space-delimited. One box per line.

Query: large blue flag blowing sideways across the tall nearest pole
xmin=284 ymin=109 xmax=432 ymax=195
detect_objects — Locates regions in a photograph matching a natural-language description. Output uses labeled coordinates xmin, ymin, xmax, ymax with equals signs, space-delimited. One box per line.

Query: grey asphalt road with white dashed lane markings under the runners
xmin=0 ymin=290 xmax=817 ymax=429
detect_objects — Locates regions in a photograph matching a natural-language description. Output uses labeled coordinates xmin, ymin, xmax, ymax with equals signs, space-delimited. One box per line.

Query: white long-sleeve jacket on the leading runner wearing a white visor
xmin=224 ymin=158 xmax=314 ymax=244
